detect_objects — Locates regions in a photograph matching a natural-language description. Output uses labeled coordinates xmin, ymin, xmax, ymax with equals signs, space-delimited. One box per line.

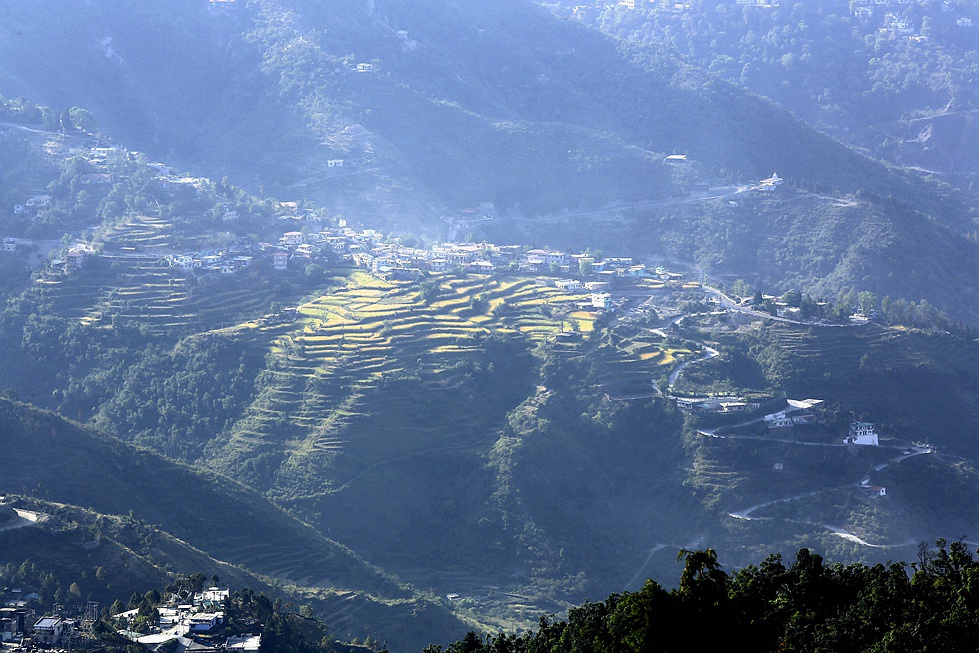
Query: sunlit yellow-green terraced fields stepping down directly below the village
xmin=212 ymin=272 xmax=594 ymax=474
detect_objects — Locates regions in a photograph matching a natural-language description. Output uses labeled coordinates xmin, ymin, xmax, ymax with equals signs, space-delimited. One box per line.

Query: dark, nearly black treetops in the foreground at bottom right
xmin=425 ymin=540 xmax=979 ymax=653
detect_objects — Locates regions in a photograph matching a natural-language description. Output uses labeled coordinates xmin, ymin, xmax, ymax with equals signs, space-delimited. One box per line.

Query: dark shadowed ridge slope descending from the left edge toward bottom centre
xmin=0 ymin=400 xmax=464 ymax=650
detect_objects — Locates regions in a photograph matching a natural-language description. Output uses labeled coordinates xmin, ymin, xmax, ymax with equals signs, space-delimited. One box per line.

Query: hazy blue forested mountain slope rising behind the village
xmin=0 ymin=0 xmax=966 ymax=228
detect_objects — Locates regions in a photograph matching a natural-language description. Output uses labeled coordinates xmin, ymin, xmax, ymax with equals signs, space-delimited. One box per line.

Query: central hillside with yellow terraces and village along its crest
xmin=7 ymin=144 xmax=974 ymax=636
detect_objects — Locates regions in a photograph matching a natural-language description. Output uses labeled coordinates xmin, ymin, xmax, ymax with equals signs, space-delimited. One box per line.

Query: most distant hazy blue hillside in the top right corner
xmin=576 ymin=0 xmax=979 ymax=193
